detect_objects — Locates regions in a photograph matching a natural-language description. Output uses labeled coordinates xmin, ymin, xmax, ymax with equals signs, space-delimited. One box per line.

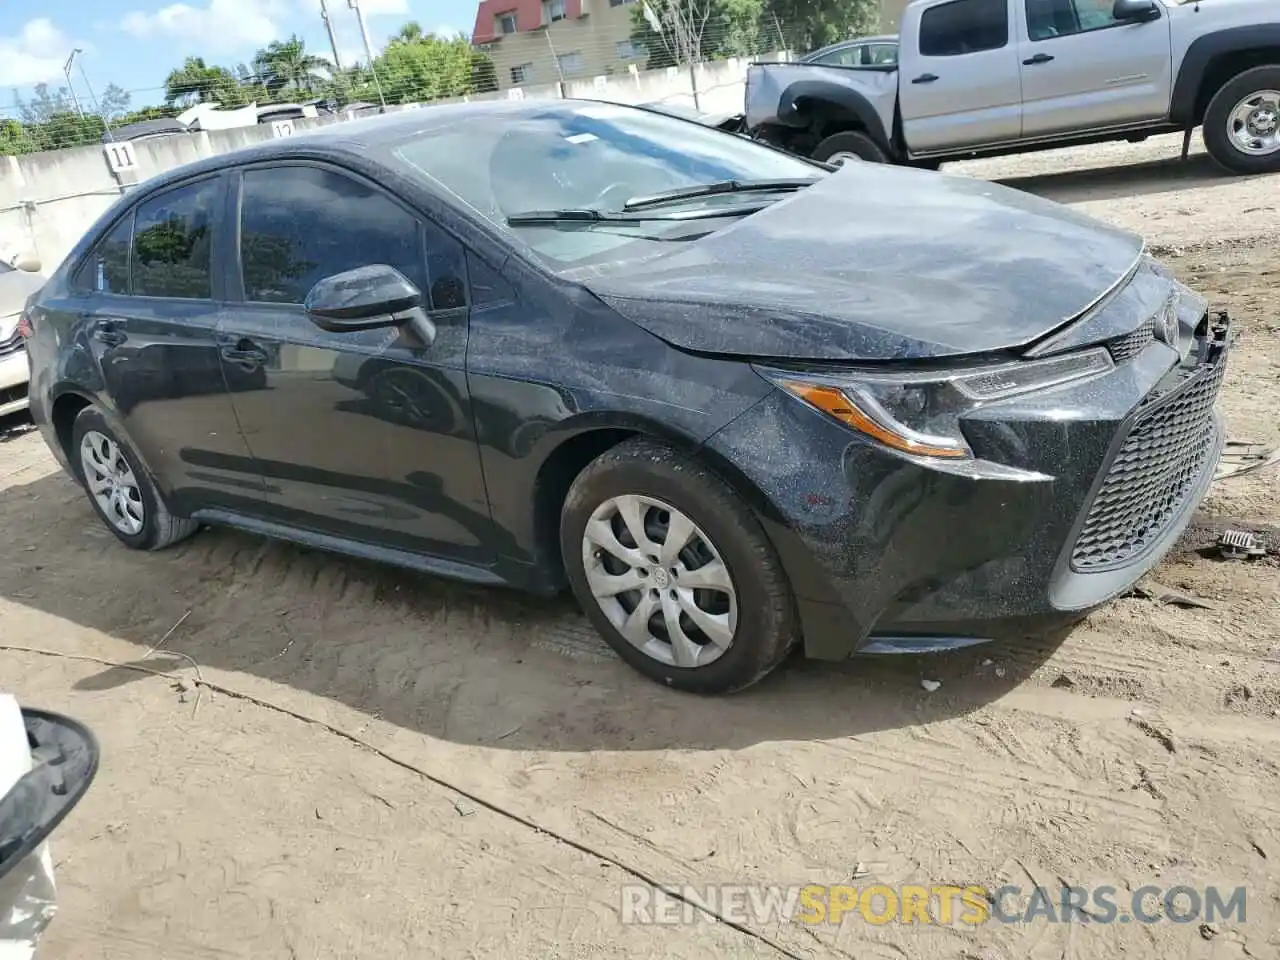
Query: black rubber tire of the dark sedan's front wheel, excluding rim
xmin=561 ymin=439 xmax=800 ymax=694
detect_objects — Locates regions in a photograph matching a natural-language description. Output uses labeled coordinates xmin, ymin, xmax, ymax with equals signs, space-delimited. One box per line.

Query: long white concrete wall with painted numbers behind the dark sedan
xmin=0 ymin=54 xmax=783 ymax=274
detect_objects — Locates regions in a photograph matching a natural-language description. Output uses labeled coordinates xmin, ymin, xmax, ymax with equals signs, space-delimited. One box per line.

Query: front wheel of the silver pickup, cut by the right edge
xmin=1204 ymin=65 xmax=1280 ymax=173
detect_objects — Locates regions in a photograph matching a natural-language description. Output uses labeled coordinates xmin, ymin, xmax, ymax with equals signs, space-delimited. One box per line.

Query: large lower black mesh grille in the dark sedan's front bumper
xmin=1071 ymin=357 xmax=1226 ymax=572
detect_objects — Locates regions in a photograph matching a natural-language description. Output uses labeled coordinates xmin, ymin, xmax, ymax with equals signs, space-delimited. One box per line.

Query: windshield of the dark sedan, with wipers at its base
xmin=394 ymin=102 xmax=826 ymax=269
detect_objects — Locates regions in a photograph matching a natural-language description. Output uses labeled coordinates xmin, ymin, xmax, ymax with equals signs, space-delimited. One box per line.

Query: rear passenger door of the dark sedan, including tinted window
xmin=68 ymin=174 xmax=261 ymax=513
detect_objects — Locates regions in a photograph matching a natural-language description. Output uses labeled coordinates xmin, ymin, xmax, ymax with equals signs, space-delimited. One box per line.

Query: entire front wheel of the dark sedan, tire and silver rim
xmin=561 ymin=440 xmax=799 ymax=694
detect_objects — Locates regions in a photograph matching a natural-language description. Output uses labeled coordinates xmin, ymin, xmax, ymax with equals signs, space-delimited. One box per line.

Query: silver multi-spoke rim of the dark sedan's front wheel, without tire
xmin=582 ymin=494 xmax=737 ymax=667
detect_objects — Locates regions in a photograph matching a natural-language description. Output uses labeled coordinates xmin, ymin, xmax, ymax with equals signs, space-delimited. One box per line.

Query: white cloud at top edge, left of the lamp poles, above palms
xmin=120 ymin=0 xmax=288 ymax=54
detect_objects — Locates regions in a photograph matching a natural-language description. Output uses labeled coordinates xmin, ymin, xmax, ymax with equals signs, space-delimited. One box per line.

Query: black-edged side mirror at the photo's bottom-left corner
xmin=0 ymin=708 xmax=99 ymax=878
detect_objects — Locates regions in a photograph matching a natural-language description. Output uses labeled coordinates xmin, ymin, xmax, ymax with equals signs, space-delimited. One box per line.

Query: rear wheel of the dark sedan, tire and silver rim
xmin=69 ymin=407 xmax=200 ymax=550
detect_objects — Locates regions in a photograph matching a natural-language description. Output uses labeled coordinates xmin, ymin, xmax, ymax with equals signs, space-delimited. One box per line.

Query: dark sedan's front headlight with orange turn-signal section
xmin=755 ymin=347 xmax=1114 ymax=460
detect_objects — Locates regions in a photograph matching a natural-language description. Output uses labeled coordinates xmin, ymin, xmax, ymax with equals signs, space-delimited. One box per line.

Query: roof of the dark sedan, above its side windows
xmin=127 ymin=99 xmax=619 ymax=197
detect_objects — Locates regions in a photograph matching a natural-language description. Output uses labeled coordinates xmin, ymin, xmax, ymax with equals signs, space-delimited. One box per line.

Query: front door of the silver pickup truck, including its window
xmin=1018 ymin=0 xmax=1174 ymax=138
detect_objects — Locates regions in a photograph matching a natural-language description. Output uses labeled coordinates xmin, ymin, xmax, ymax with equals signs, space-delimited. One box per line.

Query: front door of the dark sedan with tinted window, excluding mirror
xmin=219 ymin=164 xmax=492 ymax=563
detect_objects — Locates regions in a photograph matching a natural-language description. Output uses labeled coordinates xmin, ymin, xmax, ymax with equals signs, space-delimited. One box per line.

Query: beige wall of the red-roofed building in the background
xmin=481 ymin=0 xmax=648 ymax=90
